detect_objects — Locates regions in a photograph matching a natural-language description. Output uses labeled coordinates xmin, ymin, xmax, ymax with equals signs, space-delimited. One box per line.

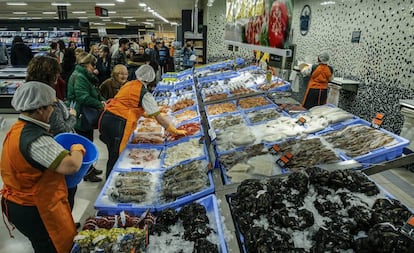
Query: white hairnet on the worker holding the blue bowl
xmin=11 ymin=81 xmax=56 ymax=112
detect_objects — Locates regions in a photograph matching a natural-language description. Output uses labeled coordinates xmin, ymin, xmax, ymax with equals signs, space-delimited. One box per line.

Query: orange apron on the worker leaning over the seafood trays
xmin=105 ymin=80 xmax=145 ymax=153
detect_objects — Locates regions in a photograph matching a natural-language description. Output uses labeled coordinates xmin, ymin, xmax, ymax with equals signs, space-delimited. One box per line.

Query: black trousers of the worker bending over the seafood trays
xmin=99 ymin=111 xmax=126 ymax=179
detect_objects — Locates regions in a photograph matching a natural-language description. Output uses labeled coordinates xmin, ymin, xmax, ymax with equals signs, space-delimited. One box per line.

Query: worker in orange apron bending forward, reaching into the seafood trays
xmin=99 ymin=64 xmax=187 ymax=178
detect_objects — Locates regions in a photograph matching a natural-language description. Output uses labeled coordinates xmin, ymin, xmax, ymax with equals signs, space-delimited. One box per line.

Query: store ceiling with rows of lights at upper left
xmin=0 ymin=0 xmax=195 ymax=29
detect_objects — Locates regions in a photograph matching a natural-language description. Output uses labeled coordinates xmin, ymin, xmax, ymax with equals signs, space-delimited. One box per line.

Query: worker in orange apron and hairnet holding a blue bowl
xmin=0 ymin=81 xmax=85 ymax=253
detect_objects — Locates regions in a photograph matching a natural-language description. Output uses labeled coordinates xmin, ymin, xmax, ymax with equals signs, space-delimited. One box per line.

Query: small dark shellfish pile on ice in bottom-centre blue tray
xmin=150 ymin=202 xmax=219 ymax=253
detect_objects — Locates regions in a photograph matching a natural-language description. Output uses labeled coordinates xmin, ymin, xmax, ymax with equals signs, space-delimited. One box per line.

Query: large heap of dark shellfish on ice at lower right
xmin=229 ymin=168 xmax=414 ymax=253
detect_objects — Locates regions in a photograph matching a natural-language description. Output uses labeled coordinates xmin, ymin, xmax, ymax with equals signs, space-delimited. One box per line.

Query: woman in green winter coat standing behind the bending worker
xmin=67 ymin=53 xmax=105 ymax=182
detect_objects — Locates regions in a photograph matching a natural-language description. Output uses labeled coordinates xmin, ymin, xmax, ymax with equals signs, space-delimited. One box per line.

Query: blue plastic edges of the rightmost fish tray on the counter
xmin=317 ymin=119 xmax=410 ymax=167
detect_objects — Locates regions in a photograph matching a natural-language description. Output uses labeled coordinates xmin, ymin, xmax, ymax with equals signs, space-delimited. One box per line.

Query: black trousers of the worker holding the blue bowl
xmin=1 ymin=198 xmax=57 ymax=253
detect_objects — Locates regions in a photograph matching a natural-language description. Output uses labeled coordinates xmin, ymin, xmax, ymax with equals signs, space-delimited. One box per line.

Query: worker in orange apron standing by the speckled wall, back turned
xmin=301 ymin=52 xmax=333 ymax=109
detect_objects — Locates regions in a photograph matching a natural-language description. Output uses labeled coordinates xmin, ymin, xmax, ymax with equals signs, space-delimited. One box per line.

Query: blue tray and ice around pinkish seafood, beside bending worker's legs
xmin=114 ymin=144 xmax=164 ymax=171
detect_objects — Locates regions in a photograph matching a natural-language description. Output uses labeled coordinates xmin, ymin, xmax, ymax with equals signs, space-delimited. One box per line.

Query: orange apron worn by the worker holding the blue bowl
xmin=1 ymin=121 xmax=77 ymax=253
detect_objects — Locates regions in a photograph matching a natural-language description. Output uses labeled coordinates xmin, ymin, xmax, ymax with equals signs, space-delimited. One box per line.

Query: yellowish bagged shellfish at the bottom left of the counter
xmin=71 ymin=227 xmax=147 ymax=253
